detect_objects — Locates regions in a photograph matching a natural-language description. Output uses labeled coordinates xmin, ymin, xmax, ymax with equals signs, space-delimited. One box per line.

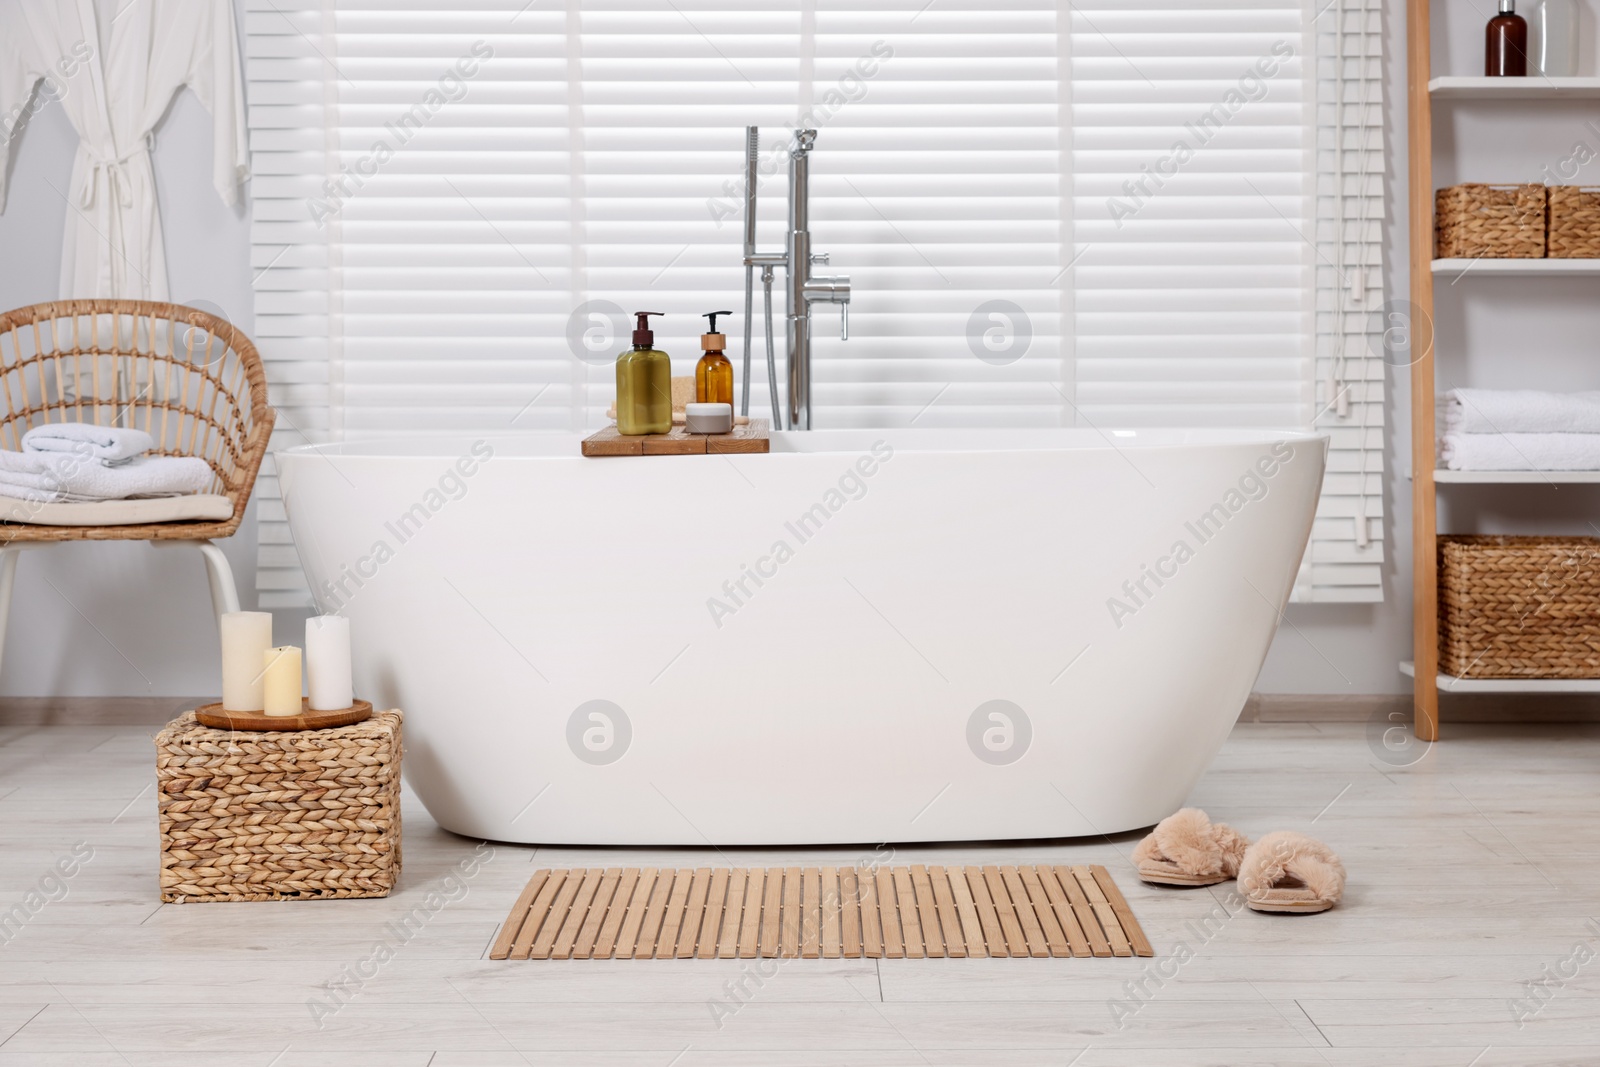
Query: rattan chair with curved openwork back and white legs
xmin=0 ymin=301 xmax=274 ymax=671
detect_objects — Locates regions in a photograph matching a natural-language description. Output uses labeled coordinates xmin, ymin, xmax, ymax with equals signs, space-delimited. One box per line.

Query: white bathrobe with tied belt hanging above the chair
xmin=0 ymin=0 xmax=250 ymax=301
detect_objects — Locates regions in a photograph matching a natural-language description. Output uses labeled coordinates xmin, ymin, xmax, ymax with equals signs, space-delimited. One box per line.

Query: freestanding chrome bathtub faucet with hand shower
xmin=739 ymin=126 xmax=850 ymax=430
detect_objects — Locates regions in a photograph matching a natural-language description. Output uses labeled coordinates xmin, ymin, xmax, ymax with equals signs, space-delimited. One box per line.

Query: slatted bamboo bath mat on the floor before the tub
xmin=490 ymin=864 xmax=1155 ymax=960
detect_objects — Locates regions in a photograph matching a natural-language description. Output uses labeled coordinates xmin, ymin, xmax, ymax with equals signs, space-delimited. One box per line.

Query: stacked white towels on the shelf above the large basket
xmin=1440 ymin=389 xmax=1600 ymax=470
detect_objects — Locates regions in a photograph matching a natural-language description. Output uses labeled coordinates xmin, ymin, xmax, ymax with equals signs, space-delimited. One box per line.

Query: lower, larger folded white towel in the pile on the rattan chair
xmin=0 ymin=451 xmax=211 ymax=504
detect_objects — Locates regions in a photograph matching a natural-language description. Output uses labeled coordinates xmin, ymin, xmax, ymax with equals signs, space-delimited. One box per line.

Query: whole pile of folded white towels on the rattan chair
xmin=0 ymin=422 xmax=213 ymax=504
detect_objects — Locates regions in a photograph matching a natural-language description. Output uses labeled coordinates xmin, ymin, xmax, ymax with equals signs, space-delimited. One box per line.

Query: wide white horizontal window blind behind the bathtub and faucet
xmin=248 ymin=0 xmax=1376 ymax=603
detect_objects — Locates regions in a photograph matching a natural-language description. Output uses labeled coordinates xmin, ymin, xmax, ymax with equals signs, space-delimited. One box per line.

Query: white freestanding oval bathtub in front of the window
xmin=277 ymin=430 xmax=1326 ymax=845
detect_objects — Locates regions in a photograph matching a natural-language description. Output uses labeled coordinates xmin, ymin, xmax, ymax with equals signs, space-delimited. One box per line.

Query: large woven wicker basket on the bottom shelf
xmin=1438 ymin=534 xmax=1600 ymax=678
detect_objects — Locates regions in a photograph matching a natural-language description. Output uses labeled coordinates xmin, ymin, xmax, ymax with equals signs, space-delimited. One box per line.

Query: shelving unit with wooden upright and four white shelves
xmin=1400 ymin=0 xmax=1600 ymax=741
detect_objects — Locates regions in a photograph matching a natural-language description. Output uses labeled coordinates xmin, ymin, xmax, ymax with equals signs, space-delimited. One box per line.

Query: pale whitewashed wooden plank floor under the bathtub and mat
xmin=0 ymin=723 xmax=1600 ymax=1067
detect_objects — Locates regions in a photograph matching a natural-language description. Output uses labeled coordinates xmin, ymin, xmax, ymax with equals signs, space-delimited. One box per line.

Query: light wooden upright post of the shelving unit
xmin=1408 ymin=0 xmax=1438 ymax=741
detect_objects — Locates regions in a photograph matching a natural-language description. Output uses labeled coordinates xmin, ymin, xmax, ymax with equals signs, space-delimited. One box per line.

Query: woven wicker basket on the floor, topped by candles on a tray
xmin=155 ymin=712 xmax=400 ymax=904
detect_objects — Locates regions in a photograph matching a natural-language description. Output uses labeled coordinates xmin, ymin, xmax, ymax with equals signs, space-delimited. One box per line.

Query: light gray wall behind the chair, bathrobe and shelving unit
xmin=0 ymin=0 xmax=1580 ymax=696
